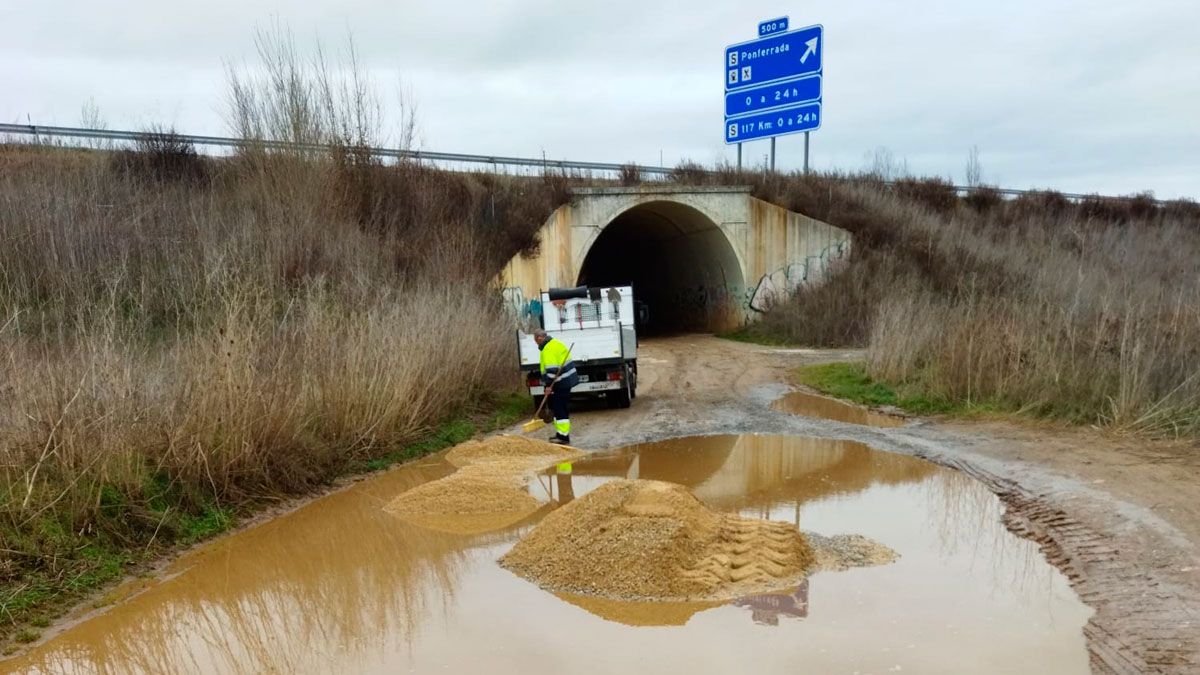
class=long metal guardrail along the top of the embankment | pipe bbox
[0,124,1168,205]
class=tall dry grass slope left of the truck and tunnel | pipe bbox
[0,28,566,641]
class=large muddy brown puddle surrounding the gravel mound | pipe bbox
[0,436,1091,674]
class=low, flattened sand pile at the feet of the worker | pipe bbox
[388,436,583,534]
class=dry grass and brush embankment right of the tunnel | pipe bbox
[678,167,1200,436]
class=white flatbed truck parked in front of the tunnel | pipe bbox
[517,286,637,408]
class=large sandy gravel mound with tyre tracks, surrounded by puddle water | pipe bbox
[500,480,814,601]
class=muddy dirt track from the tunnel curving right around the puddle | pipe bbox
[572,335,1200,673]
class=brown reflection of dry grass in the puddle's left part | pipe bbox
[8,456,501,673]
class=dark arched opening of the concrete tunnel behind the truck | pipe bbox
[578,202,745,334]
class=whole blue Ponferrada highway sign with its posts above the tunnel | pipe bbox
[725,22,824,172]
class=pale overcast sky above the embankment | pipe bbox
[0,0,1200,198]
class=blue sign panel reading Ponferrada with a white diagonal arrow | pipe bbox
[725,25,824,91]
